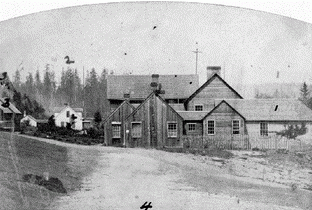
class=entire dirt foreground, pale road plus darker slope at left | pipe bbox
[0,136,312,210]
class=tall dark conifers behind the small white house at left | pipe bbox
[13,64,113,118]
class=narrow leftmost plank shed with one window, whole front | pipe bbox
[103,100,135,146]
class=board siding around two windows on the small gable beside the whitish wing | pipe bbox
[204,103,245,137]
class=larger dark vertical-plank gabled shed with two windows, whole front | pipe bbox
[125,92,183,148]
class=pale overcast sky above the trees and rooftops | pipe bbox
[0,0,312,90]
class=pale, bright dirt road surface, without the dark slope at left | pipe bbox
[47,147,311,209]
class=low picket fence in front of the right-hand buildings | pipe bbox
[182,135,306,151]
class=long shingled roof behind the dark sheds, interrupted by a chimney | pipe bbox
[107,74,199,99]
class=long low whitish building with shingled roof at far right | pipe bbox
[226,99,312,138]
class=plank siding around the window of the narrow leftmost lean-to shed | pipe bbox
[104,103,133,145]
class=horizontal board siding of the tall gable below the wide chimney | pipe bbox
[187,77,240,111]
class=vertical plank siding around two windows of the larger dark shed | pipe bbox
[126,95,183,148]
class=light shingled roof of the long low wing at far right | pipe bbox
[216,99,312,121]
